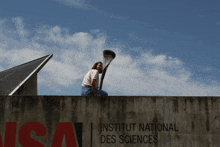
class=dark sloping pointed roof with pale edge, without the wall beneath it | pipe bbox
[0,54,53,95]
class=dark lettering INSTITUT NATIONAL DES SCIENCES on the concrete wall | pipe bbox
[100,123,178,144]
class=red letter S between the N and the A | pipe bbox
[18,122,46,147]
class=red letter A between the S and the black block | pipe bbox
[51,122,77,147]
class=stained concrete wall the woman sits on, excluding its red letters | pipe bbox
[0,96,220,147]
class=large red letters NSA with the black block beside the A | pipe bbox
[0,122,82,147]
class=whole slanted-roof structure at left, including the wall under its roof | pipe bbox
[0,54,53,96]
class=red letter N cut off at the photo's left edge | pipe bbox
[0,122,17,147]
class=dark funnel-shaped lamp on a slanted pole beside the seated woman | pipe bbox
[99,50,116,90]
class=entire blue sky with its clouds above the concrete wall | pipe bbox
[0,0,220,96]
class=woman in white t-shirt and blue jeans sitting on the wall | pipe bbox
[81,61,108,97]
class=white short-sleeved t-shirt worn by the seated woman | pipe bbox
[82,69,99,89]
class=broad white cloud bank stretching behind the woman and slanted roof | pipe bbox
[0,18,220,96]
